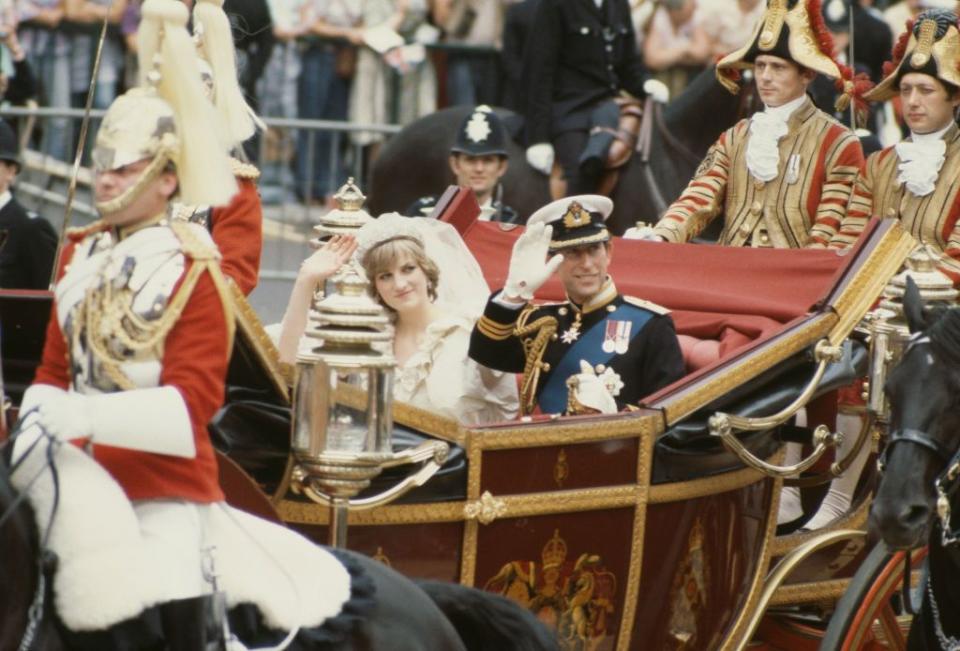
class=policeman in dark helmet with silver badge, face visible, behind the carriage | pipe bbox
[407,104,519,224]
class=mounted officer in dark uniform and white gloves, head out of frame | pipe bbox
[523,0,645,194]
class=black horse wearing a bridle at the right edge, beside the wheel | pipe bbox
[869,281,960,651]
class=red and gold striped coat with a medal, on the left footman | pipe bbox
[655,98,863,248]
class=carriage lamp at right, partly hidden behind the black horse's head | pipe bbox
[863,244,958,425]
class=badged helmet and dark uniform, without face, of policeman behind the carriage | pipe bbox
[404,104,520,224]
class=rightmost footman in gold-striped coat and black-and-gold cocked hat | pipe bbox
[831,9,960,285]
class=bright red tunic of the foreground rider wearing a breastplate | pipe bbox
[34,229,229,502]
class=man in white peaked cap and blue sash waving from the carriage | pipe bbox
[470,195,684,413]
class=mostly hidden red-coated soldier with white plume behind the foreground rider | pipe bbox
[172,0,263,295]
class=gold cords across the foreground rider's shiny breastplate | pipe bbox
[71,224,236,390]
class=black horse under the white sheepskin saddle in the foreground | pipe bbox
[0,432,558,651]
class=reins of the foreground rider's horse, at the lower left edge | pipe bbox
[0,409,61,651]
